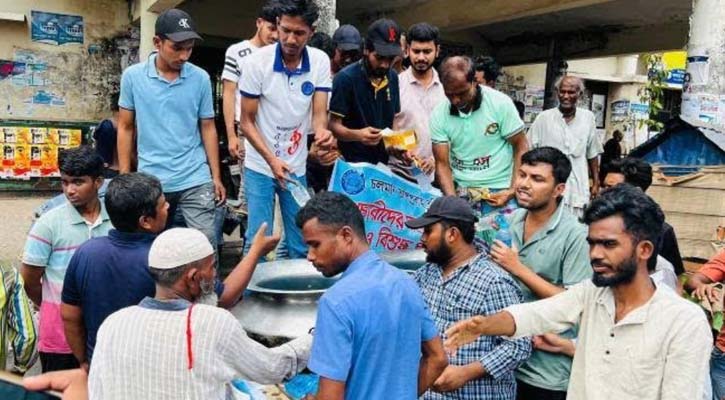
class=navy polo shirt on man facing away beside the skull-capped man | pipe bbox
[61,229,156,360]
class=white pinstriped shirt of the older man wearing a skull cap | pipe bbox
[89,304,312,400]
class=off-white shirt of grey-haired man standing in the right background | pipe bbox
[528,108,604,208]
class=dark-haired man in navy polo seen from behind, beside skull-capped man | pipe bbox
[60,173,169,368]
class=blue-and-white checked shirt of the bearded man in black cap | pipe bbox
[414,244,531,400]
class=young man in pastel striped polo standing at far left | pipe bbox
[20,146,112,372]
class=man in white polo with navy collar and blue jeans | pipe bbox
[239,0,334,258]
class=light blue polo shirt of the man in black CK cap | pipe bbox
[118,53,214,192]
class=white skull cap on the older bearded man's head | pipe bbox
[149,228,214,269]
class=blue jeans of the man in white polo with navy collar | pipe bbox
[244,168,307,258]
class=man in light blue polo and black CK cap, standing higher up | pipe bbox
[118,9,226,245]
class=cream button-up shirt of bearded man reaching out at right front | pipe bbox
[506,281,712,400]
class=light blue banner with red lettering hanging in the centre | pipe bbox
[329,160,441,251]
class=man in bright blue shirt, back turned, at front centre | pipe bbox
[297,192,448,400]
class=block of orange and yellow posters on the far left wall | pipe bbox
[0,126,82,179]
